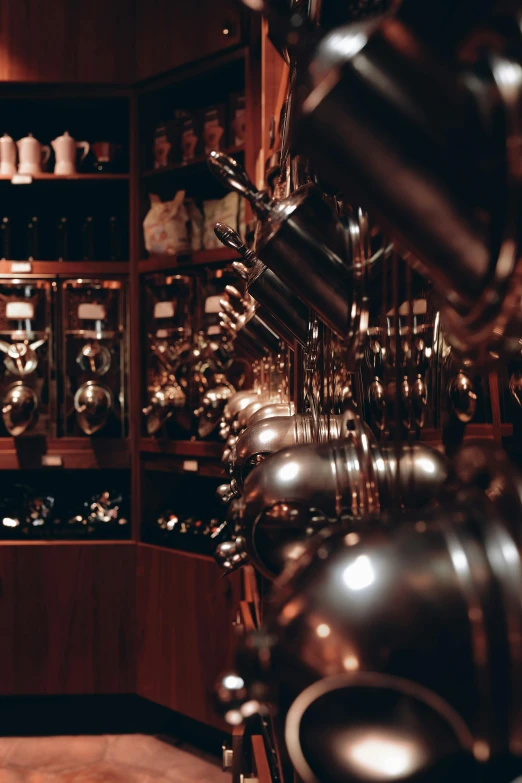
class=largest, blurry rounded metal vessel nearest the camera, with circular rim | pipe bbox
[239,494,522,783]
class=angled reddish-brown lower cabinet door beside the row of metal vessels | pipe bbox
[137,544,240,728]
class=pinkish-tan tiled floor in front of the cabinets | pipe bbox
[0,734,230,783]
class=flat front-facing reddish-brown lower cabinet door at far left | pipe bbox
[0,542,136,696]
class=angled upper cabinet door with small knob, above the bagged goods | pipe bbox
[136,0,241,80]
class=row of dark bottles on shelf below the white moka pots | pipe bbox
[0,215,125,261]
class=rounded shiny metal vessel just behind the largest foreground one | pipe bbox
[240,438,450,579]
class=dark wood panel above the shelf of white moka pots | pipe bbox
[0,0,133,82]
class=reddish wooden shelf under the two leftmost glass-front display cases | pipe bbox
[0,435,130,470]
